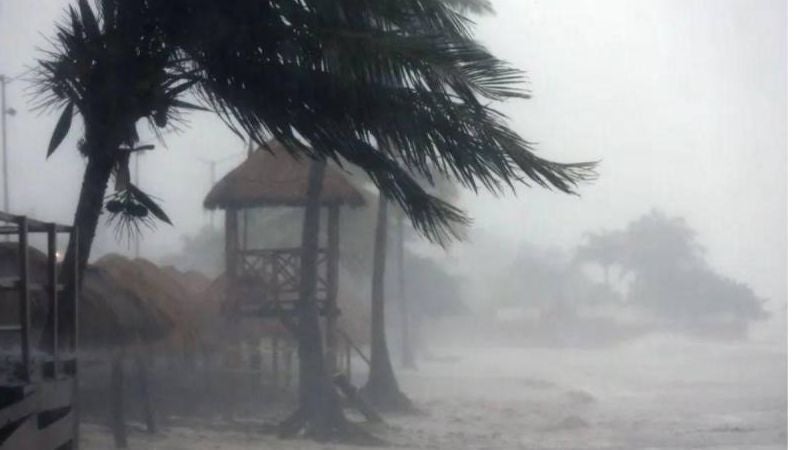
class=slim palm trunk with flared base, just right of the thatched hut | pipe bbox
[362,194,411,411]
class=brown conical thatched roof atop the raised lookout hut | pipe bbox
[203,141,364,209]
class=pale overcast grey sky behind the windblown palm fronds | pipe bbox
[0,0,787,308]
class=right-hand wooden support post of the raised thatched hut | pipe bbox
[325,204,339,374]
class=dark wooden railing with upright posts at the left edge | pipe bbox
[0,212,78,450]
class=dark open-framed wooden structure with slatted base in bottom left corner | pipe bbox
[0,213,78,450]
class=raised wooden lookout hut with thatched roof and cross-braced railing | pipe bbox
[204,141,364,368]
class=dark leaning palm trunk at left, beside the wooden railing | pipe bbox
[39,135,114,352]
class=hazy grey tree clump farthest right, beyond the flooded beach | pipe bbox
[579,210,767,337]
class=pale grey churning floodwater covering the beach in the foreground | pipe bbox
[82,337,787,450]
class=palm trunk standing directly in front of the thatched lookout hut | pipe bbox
[281,161,350,440]
